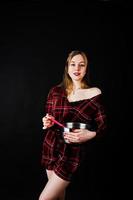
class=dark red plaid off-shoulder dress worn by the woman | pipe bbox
[41,86,106,181]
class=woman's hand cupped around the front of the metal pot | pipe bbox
[64,129,96,143]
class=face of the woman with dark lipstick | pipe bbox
[68,54,87,81]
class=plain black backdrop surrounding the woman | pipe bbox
[0,1,132,200]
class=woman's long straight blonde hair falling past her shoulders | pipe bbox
[60,50,89,95]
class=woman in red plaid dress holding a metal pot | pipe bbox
[39,51,106,200]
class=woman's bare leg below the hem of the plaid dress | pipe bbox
[39,171,70,200]
